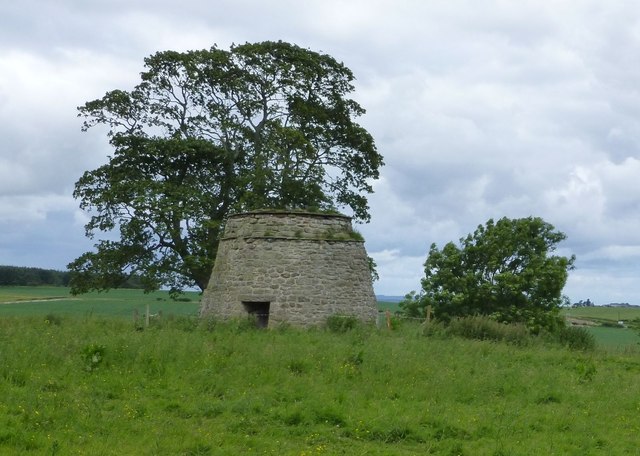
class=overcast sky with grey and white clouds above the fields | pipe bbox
[0,0,640,304]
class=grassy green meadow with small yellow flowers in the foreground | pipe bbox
[0,290,640,456]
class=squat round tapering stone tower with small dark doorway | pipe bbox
[200,211,377,327]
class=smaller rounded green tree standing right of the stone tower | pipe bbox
[400,217,575,332]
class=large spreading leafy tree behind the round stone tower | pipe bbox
[69,42,383,293]
